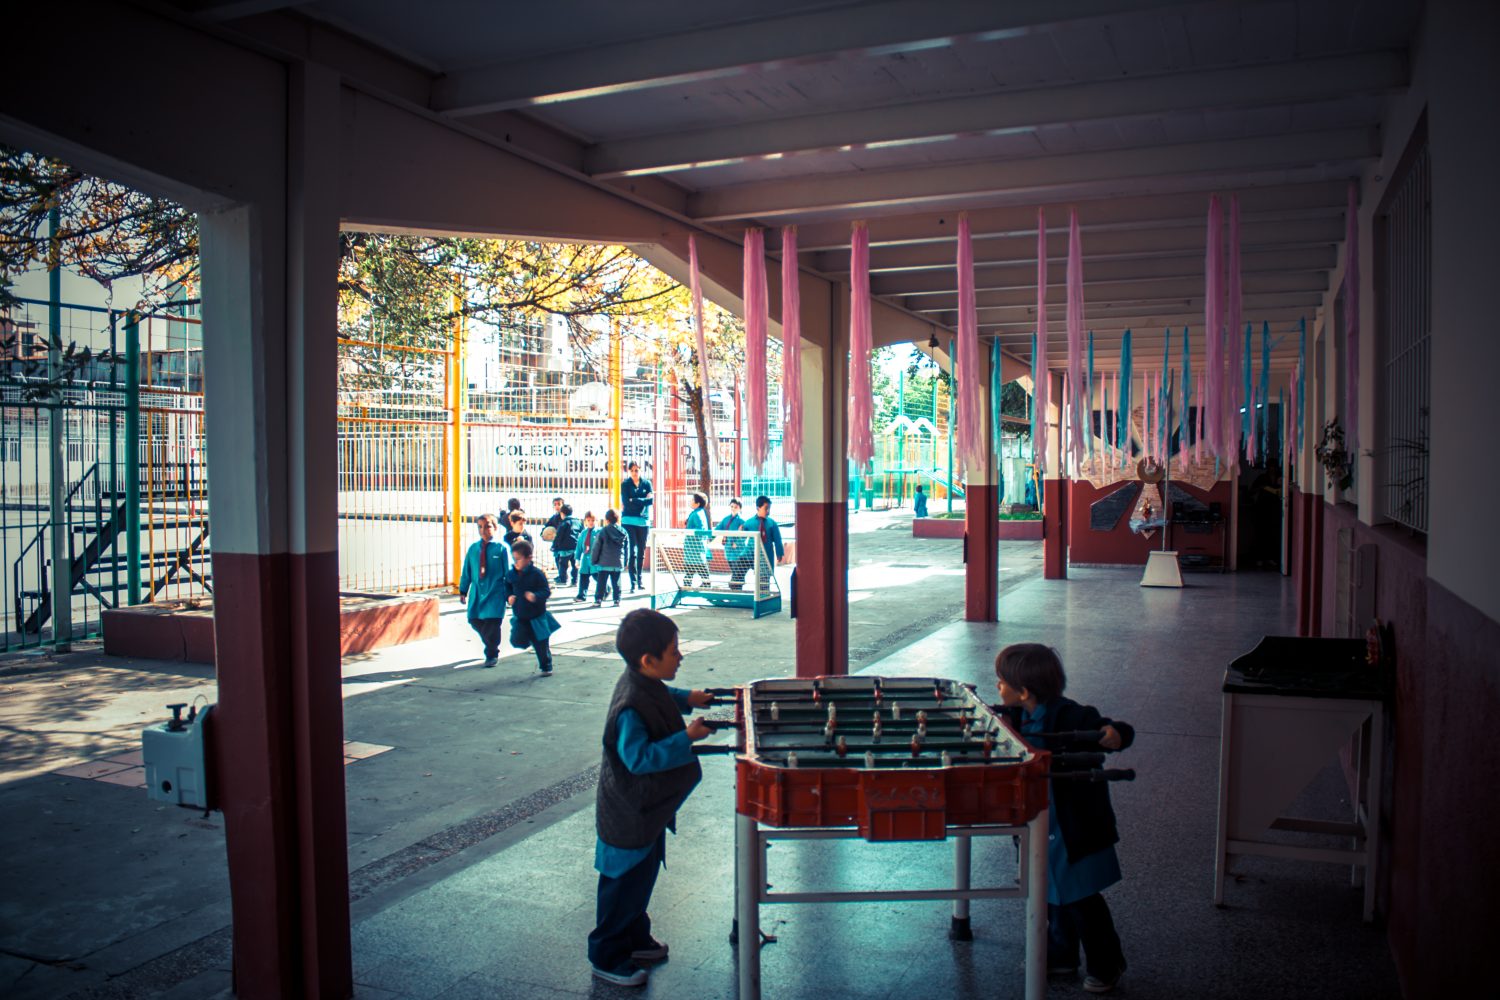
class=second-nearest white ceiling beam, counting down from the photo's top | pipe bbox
[584,52,1407,184]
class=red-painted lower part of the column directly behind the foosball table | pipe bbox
[797,501,849,678]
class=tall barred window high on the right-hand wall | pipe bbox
[1376,123,1433,532]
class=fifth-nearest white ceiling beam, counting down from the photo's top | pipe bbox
[800,217,1344,280]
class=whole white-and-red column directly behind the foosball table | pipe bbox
[797,280,849,678]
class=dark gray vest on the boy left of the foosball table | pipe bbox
[594,669,704,850]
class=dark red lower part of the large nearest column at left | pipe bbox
[209,552,354,1000]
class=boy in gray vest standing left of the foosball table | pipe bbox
[588,609,713,987]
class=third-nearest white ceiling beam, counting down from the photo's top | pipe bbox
[687,127,1380,222]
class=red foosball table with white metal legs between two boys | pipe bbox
[699,676,1130,1000]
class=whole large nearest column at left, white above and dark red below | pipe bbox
[201,66,353,999]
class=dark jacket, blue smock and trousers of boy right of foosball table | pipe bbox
[1008,696,1136,982]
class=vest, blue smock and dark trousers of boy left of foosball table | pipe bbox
[588,669,704,972]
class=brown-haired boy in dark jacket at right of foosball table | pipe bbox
[995,643,1136,993]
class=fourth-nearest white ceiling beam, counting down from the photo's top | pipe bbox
[786,180,1349,253]
